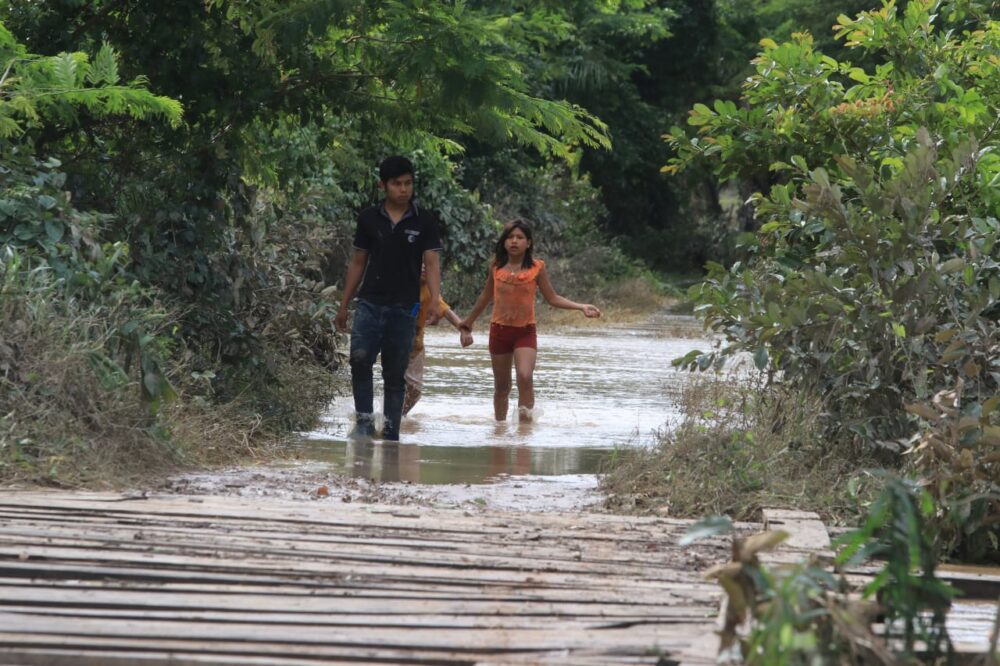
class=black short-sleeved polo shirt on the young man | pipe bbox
[354,204,441,307]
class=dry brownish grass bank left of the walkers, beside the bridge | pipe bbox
[0,276,333,487]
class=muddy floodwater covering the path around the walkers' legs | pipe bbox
[303,316,706,484]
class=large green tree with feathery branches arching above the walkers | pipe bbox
[8,0,607,290]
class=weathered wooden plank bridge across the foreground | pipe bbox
[0,490,729,666]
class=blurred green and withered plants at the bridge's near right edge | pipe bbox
[685,477,956,666]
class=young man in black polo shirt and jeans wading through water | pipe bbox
[335,155,441,441]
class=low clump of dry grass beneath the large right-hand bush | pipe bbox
[602,370,877,522]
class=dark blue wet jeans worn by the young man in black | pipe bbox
[351,299,417,439]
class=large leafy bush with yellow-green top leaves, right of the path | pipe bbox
[667,0,1000,452]
